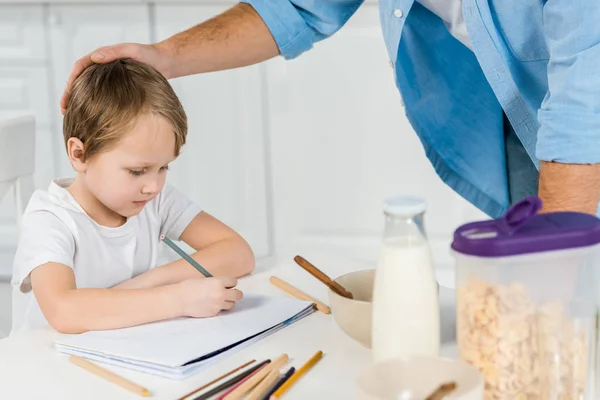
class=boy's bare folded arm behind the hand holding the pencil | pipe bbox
[114,211,255,289]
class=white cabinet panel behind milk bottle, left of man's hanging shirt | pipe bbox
[267,3,486,265]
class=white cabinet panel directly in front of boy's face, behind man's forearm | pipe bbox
[156,4,272,257]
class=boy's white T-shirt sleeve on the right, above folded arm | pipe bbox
[158,183,202,240]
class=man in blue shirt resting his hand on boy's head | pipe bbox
[61,0,600,217]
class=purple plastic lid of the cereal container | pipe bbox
[452,196,600,257]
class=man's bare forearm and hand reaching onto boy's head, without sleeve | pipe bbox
[60,3,279,113]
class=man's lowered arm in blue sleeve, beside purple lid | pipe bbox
[537,0,600,215]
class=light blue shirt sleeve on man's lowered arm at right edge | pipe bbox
[536,0,600,164]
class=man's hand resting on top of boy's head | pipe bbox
[60,43,168,114]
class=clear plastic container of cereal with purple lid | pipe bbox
[452,197,600,400]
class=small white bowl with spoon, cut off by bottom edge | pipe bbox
[356,356,484,400]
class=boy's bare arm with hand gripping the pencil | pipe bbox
[31,263,241,333]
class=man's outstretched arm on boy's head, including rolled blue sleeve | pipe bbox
[60,0,364,113]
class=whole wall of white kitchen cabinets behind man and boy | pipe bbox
[0,0,485,337]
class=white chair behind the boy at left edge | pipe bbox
[0,115,35,338]
